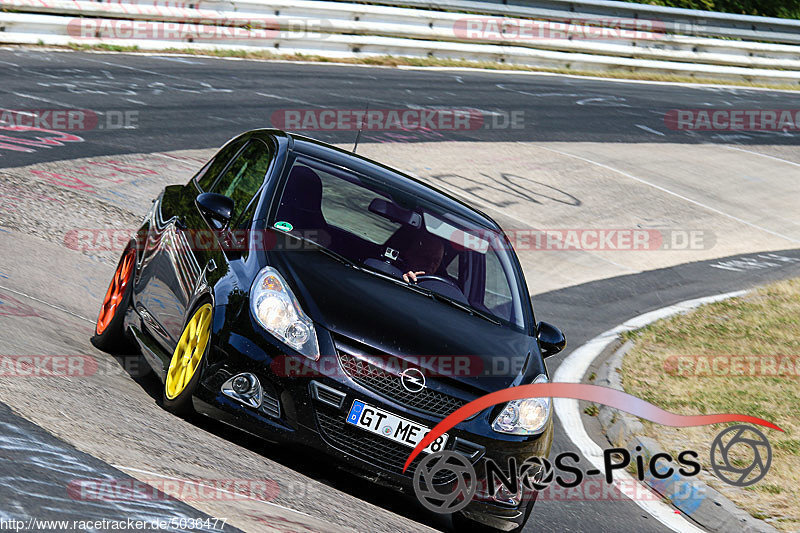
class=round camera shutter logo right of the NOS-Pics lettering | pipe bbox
[711,425,772,487]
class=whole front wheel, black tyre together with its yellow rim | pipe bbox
[162,302,212,417]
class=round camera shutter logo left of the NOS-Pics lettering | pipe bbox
[414,451,478,513]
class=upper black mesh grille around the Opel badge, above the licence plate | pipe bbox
[337,350,467,418]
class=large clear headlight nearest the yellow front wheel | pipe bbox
[250,267,319,361]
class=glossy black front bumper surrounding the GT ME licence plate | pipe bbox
[194,306,553,529]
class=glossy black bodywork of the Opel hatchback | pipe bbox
[120,130,553,523]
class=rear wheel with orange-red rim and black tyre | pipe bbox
[91,246,136,353]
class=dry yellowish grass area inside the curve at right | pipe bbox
[622,279,800,531]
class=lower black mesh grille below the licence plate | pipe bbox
[316,406,456,485]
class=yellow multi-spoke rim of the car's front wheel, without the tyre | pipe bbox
[164,304,211,410]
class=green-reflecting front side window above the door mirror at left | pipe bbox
[210,139,272,221]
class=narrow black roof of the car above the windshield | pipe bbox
[261,130,502,232]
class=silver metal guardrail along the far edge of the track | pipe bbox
[0,0,800,83]
